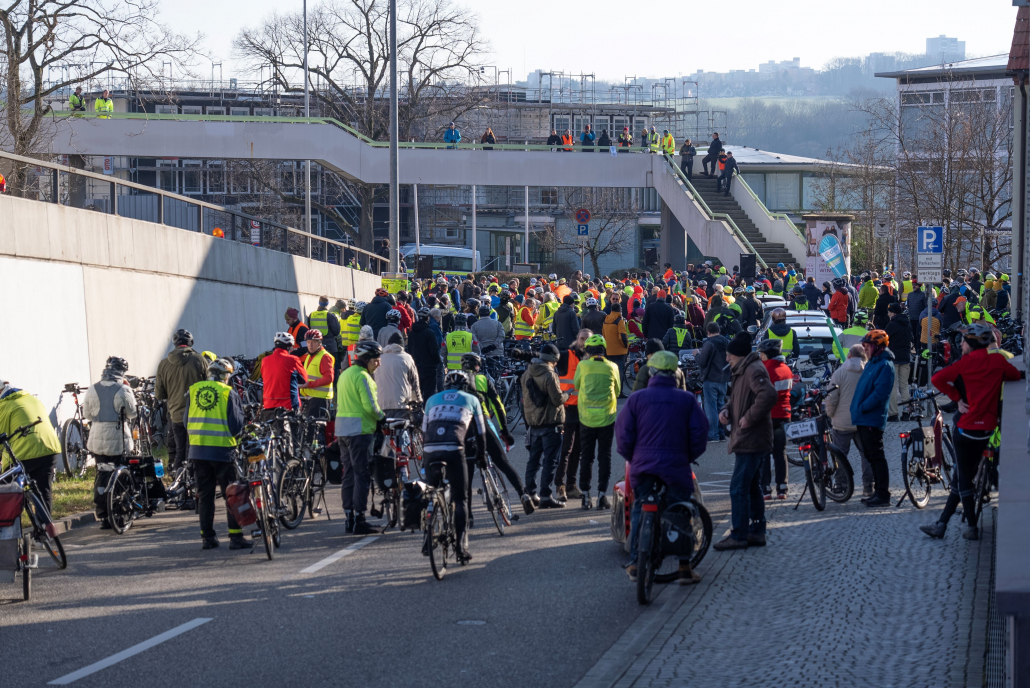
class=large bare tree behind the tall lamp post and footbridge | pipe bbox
[235,0,486,249]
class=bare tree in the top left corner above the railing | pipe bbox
[0,0,200,193]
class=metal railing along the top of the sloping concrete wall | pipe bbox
[0,150,389,274]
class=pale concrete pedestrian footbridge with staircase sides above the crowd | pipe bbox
[53,113,804,268]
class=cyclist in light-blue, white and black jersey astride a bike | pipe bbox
[422,370,486,561]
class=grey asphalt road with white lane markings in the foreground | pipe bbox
[0,399,731,688]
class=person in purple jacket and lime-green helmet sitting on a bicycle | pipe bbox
[616,351,709,585]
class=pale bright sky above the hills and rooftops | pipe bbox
[160,0,1016,81]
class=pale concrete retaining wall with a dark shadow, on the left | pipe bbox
[0,196,380,414]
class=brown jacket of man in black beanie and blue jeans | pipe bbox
[723,351,778,454]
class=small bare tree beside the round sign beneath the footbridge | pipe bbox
[542,186,640,276]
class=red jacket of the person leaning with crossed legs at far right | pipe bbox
[930,349,1020,433]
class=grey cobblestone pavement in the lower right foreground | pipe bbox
[578,423,993,688]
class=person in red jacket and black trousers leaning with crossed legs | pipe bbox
[919,322,1022,540]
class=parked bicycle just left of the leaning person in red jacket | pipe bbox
[897,387,956,509]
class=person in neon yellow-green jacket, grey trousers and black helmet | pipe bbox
[336,340,386,535]
